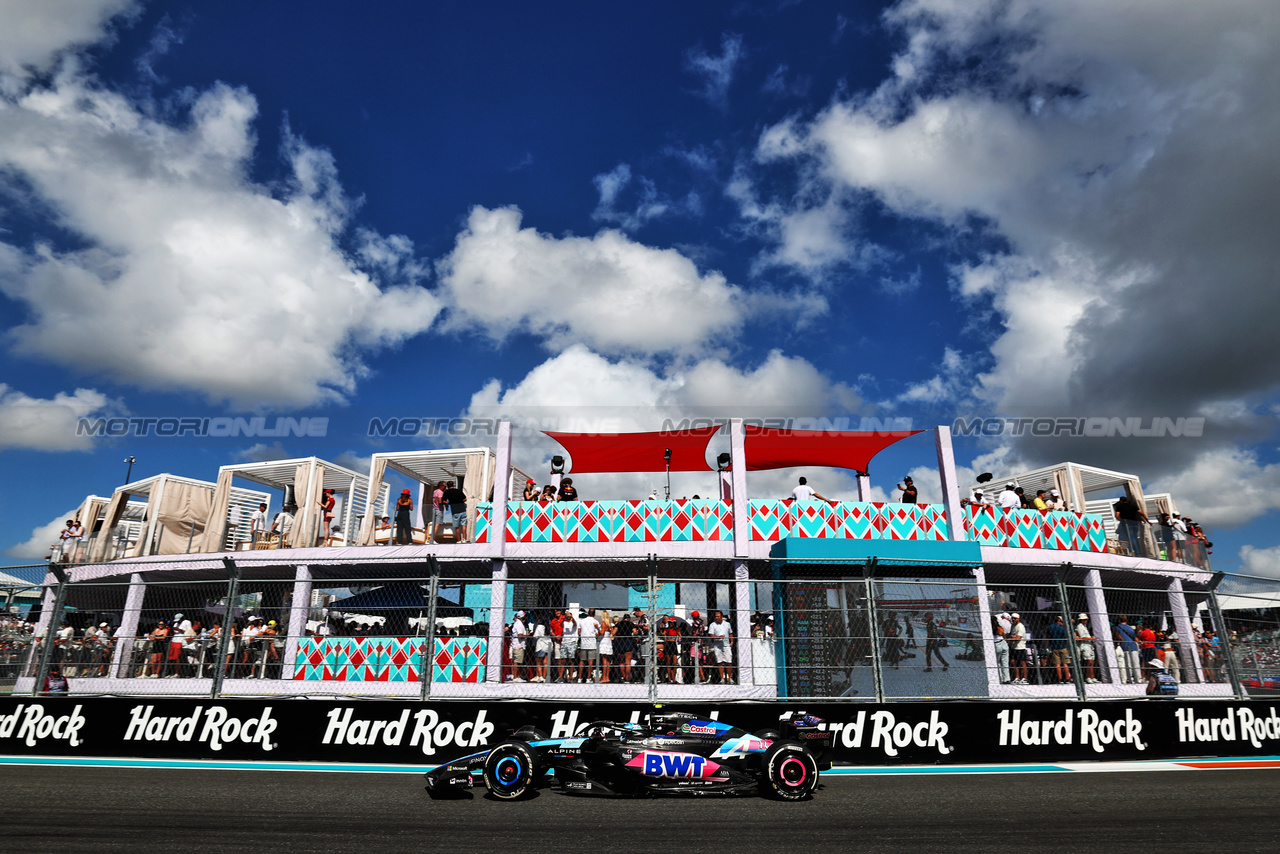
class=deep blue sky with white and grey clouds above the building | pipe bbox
[0,0,1280,574]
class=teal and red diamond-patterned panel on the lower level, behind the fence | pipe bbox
[293,638,489,682]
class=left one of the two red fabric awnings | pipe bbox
[545,425,719,475]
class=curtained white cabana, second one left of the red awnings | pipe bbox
[202,457,387,552]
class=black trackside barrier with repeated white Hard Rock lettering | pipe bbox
[0,695,1280,769]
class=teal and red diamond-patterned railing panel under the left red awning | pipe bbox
[507,498,733,543]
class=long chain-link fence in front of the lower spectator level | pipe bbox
[10,560,1280,702]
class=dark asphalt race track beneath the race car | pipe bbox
[0,766,1280,854]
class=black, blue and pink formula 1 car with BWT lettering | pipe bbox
[426,712,832,800]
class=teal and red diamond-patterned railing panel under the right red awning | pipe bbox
[749,498,947,542]
